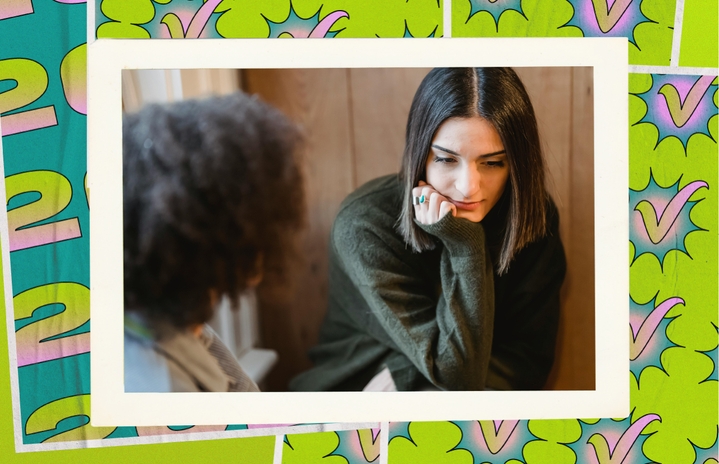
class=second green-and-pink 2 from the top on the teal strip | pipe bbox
[5,171,82,251]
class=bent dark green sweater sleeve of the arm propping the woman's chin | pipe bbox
[333,210,494,390]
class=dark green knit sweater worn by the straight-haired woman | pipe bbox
[290,175,565,391]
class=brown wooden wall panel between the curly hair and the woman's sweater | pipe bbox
[243,69,354,390]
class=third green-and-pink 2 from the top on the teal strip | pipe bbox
[13,282,90,367]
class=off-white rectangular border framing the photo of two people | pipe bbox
[88,38,629,426]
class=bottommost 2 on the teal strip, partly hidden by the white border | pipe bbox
[25,395,117,443]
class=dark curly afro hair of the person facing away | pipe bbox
[123,93,304,327]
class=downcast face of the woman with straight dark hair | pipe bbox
[426,116,509,222]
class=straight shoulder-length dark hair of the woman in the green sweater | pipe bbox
[398,68,548,274]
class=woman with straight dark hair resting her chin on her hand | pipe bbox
[291,68,566,391]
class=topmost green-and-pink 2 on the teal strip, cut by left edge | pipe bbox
[0,58,57,136]
